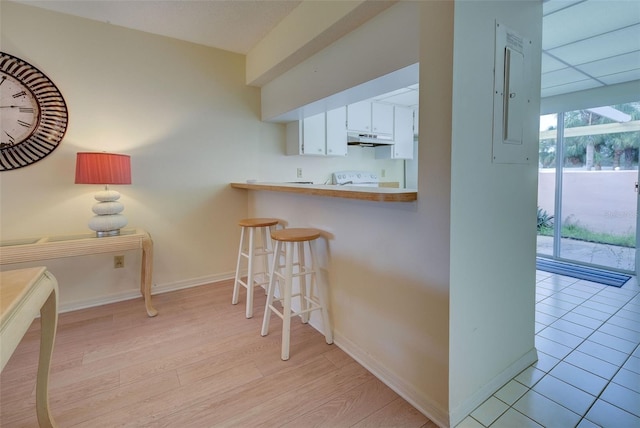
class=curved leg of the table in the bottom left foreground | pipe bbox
[36,273,58,427]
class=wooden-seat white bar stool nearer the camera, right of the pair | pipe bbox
[261,228,333,361]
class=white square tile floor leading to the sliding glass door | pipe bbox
[458,271,640,428]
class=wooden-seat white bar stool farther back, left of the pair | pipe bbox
[231,218,280,318]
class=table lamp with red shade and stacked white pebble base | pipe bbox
[76,152,131,237]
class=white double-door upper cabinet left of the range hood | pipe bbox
[286,107,347,156]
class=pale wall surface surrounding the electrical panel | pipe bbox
[448,1,542,420]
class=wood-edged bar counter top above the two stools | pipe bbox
[231,182,418,202]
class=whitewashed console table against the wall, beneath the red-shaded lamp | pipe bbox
[0,229,158,317]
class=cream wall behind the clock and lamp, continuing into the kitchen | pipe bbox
[0,1,403,313]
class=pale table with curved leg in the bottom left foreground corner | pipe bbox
[0,267,58,427]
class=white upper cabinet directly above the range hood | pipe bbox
[347,101,393,136]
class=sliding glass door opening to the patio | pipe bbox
[538,103,640,273]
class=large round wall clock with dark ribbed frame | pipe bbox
[0,52,68,171]
